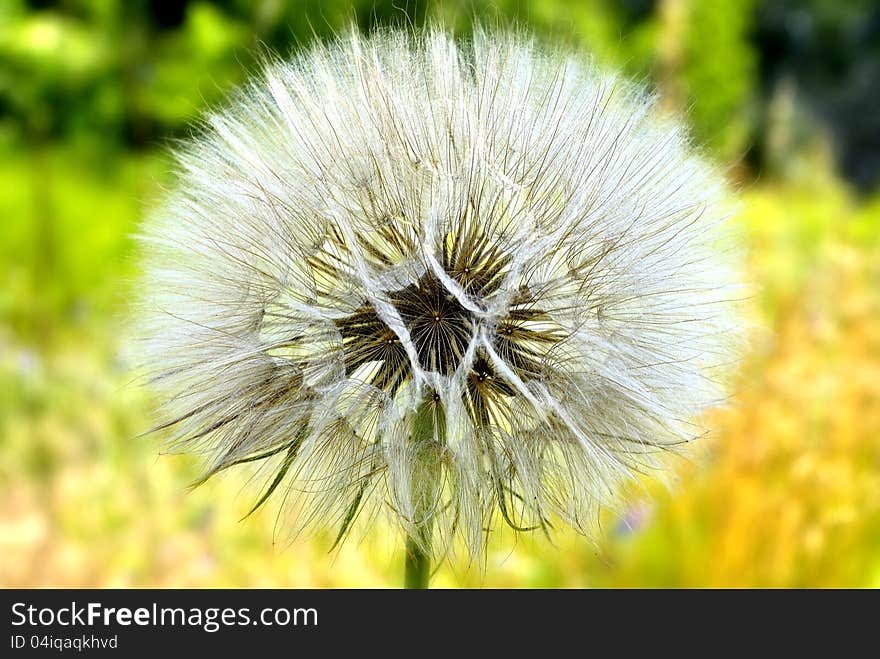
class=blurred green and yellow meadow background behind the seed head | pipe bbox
[0,0,880,587]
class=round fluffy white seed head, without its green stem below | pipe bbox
[138,31,738,564]
